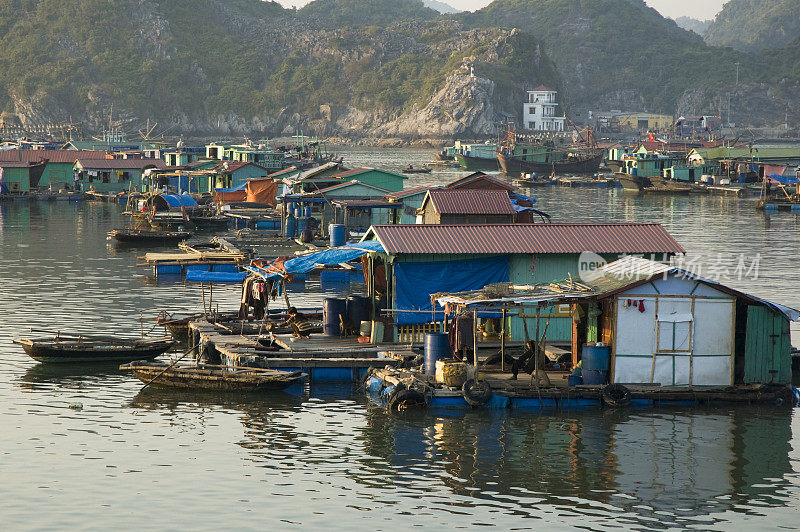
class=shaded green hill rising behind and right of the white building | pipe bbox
[463,0,743,113]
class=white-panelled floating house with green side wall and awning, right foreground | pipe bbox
[439,256,800,388]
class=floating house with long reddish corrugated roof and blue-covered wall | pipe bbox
[363,224,685,342]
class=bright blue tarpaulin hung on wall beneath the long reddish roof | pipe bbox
[394,256,510,325]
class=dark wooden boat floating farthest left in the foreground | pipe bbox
[14,336,175,363]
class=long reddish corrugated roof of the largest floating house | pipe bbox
[371,223,686,254]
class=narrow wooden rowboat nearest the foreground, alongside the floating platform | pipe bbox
[119,361,308,392]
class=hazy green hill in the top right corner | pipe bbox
[704,0,800,52]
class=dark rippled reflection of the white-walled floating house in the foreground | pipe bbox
[354,408,793,527]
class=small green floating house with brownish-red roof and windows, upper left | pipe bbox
[74,159,166,192]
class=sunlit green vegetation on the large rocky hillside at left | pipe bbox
[0,0,557,132]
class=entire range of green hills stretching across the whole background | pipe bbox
[0,0,800,134]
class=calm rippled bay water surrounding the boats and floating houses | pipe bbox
[0,150,800,530]
